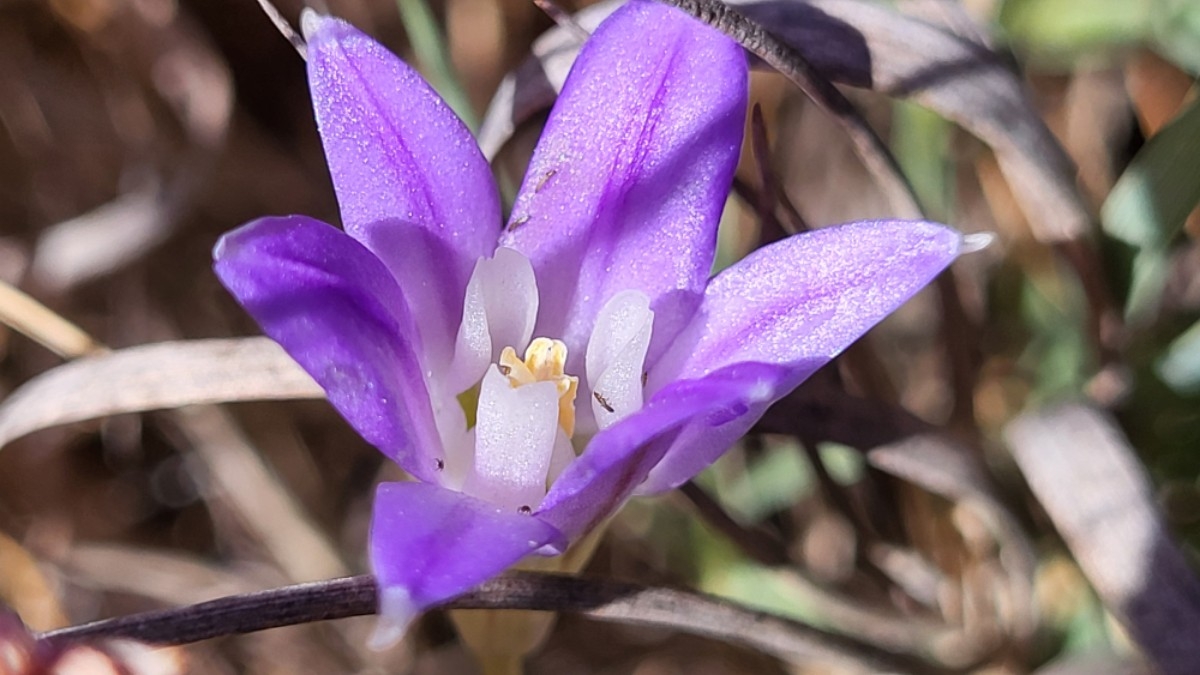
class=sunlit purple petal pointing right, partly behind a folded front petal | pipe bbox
[638,221,962,494]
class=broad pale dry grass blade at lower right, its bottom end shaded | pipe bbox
[1004,404,1200,675]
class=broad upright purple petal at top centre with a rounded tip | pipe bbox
[500,0,746,370]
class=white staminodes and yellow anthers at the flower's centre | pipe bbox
[431,249,654,510]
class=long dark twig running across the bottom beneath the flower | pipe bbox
[41,573,941,673]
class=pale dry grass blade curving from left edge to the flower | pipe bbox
[0,338,324,448]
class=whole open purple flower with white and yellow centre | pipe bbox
[215,0,961,625]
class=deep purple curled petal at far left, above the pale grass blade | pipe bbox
[212,216,442,480]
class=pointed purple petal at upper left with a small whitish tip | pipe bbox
[304,12,500,357]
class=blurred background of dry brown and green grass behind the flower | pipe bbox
[0,0,1200,675]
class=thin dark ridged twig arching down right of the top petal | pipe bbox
[661,0,922,219]
